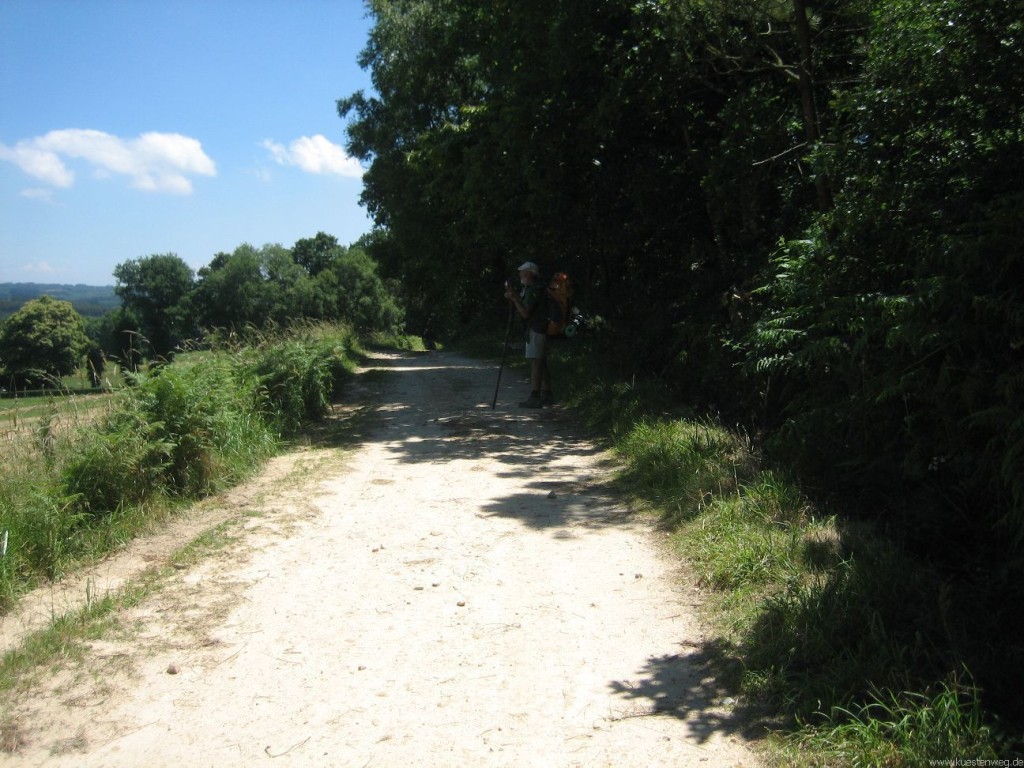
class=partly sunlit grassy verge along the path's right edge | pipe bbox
[554,345,1021,766]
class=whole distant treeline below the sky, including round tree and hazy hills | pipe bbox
[0,232,404,391]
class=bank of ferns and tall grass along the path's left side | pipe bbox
[0,326,411,612]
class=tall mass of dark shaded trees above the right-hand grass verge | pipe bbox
[338,0,1024,733]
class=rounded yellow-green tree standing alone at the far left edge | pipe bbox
[0,296,89,387]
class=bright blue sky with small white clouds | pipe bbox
[0,0,371,286]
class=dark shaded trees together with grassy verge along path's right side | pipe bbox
[346,0,1024,764]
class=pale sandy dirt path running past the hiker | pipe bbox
[0,352,757,768]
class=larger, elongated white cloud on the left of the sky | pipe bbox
[0,128,217,195]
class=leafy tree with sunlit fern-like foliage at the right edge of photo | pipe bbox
[754,0,1024,518]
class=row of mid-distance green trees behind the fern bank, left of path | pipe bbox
[105,232,404,360]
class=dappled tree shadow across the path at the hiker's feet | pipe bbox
[307,353,628,528]
